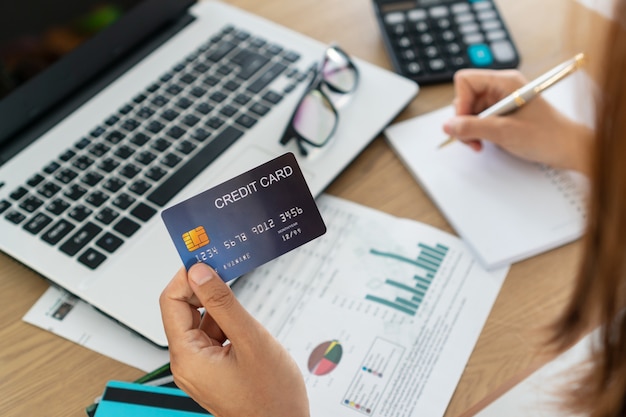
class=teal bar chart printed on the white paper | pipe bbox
[365,243,448,316]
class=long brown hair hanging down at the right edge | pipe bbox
[554,0,626,417]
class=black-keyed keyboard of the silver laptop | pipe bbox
[0,26,309,269]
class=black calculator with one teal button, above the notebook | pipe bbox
[373,0,520,84]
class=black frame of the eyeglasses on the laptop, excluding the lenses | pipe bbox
[279,44,359,156]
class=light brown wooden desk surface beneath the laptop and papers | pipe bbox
[0,0,580,417]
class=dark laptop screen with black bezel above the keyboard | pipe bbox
[0,0,192,164]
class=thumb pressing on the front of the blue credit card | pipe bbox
[187,263,259,343]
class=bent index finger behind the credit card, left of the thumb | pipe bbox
[159,268,200,344]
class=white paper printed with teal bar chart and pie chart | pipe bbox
[233,195,508,417]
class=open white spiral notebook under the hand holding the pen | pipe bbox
[385,72,593,268]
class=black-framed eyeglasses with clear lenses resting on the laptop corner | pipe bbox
[280,45,359,156]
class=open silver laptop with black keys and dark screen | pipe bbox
[0,0,418,347]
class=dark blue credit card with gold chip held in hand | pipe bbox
[161,153,326,281]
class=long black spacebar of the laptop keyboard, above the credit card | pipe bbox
[147,126,243,207]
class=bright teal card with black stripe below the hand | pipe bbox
[95,381,212,417]
